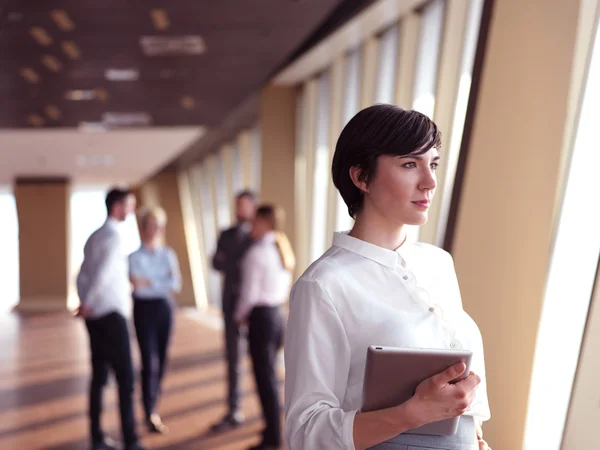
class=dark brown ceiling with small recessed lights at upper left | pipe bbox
[0,0,341,128]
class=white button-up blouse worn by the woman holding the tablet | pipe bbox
[285,233,490,450]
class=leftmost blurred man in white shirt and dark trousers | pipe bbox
[77,189,143,450]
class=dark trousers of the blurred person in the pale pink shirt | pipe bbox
[248,307,283,446]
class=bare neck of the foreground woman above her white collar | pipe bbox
[349,207,406,250]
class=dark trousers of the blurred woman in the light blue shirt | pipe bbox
[133,298,173,418]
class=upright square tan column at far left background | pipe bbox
[14,179,71,312]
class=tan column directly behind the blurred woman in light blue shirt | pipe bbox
[139,171,196,307]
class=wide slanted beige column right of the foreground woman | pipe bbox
[452,0,579,450]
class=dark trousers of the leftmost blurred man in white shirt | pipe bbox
[86,313,137,446]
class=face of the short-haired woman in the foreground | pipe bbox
[363,148,440,225]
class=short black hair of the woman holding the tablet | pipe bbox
[331,104,442,218]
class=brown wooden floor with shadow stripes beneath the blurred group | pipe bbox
[0,312,282,450]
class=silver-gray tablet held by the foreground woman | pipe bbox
[361,345,472,436]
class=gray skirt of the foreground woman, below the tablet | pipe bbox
[368,416,479,450]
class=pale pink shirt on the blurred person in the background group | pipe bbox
[234,232,292,322]
